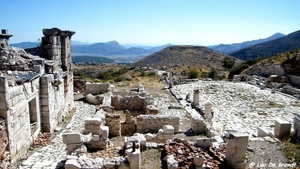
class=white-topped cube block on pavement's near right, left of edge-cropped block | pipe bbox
[274,119,292,139]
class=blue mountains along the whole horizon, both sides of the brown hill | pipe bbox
[12,31,300,63]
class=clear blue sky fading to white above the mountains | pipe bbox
[0,0,300,46]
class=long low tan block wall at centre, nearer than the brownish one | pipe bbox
[136,115,180,133]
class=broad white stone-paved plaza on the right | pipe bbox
[172,81,300,137]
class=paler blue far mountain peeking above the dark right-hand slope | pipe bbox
[208,33,285,54]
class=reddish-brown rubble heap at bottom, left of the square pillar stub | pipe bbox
[163,138,229,168]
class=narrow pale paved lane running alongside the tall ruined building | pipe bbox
[19,101,95,169]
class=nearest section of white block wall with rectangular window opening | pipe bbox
[0,77,41,162]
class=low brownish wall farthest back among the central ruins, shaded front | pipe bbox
[111,95,147,110]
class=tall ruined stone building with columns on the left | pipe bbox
[0,28,75,162]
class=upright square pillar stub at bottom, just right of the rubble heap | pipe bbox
[225,132,249,169]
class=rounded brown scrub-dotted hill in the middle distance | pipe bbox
[133,46,240,70]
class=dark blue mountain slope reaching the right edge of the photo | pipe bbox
[229,30,300,60]
